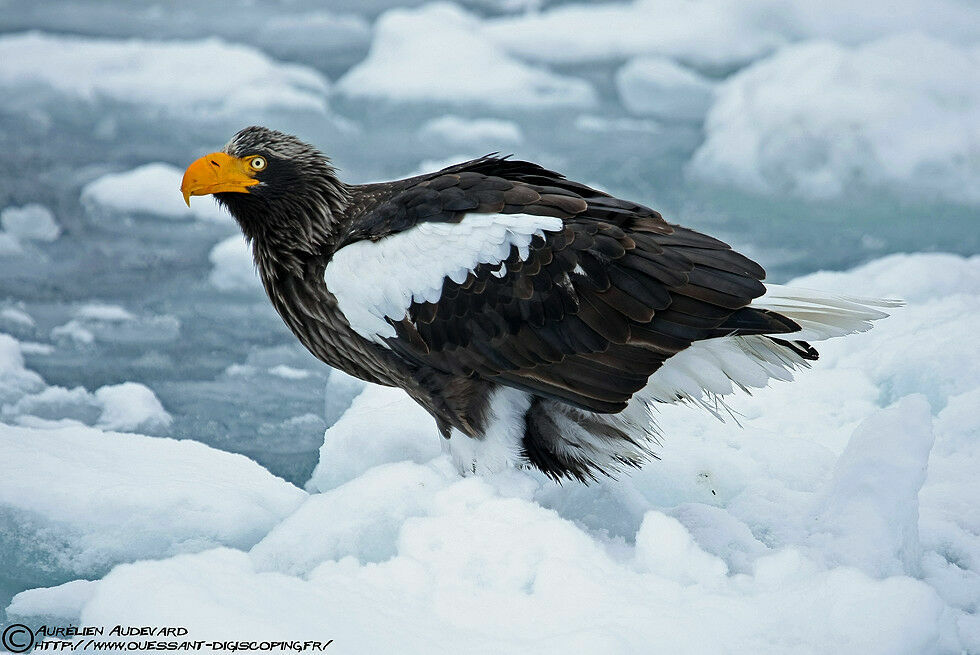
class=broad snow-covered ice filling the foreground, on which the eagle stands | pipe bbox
[0,255,980,654]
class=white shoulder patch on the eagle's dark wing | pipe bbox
[324,214,563,343]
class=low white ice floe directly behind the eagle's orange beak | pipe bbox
[82,162,231,222]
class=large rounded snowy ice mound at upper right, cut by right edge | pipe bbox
[689,34,980,204]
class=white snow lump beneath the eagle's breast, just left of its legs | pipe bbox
[306,384,442,491]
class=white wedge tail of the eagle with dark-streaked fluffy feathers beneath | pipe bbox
[523,285,903,482]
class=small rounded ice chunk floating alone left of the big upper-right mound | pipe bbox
[616,57,714,120]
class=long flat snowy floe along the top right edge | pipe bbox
[484,0,980,70]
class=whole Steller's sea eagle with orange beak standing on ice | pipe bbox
[181,127,894,481]
